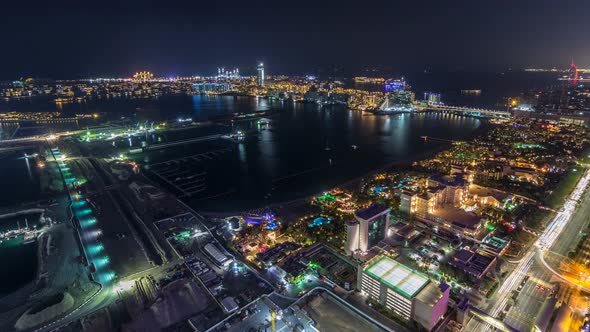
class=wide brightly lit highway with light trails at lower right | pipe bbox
[465,171,590,332]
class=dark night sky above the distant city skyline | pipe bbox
[0,0,590,79]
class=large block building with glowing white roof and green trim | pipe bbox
[358,256,450,331]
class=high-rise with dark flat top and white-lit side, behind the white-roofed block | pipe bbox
[354,203,390,251]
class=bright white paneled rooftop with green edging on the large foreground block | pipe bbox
[365,256,430,298]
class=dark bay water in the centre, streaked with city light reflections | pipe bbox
[121,96,482,211]
